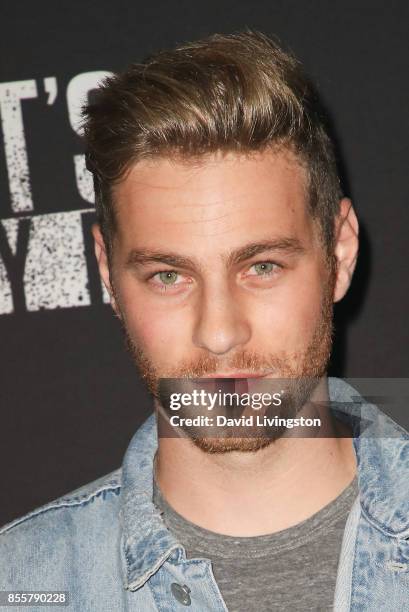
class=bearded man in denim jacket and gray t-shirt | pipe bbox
[0,32,409,612]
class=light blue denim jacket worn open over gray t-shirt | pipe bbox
[0,379,409,612]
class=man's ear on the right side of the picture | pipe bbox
[334,198,359,302]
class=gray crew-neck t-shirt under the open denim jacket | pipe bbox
[153,470,358,612]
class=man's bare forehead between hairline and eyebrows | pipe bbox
[113,151,312,254]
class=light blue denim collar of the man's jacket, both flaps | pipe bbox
[121,378,409,590]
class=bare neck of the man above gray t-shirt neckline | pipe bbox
[155,378,356,536]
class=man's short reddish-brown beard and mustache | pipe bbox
[117,258,336,453]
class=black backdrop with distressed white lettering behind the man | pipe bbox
[0,0,409,524]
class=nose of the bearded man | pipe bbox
[193,286,251,355]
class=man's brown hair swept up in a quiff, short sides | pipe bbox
[83,31,342,259]
